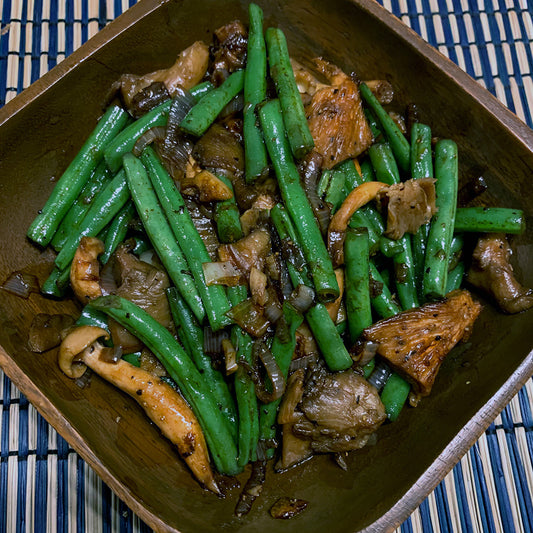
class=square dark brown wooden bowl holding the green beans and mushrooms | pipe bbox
[0,0,533,533]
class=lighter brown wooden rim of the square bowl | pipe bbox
[0,0,533,533]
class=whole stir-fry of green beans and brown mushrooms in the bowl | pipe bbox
[13,4,533,518]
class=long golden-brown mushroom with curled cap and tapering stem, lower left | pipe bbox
[59,326,220,494]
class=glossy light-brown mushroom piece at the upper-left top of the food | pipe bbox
[119,41,209,112]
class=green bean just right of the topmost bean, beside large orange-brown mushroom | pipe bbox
[265,28,315,159]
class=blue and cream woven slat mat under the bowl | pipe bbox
[0,0,533,533]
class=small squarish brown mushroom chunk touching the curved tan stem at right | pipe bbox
[376,178,437,240]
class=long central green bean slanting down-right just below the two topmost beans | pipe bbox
[259,100,339,301]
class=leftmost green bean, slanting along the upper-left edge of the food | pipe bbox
[27,106,128,246]
